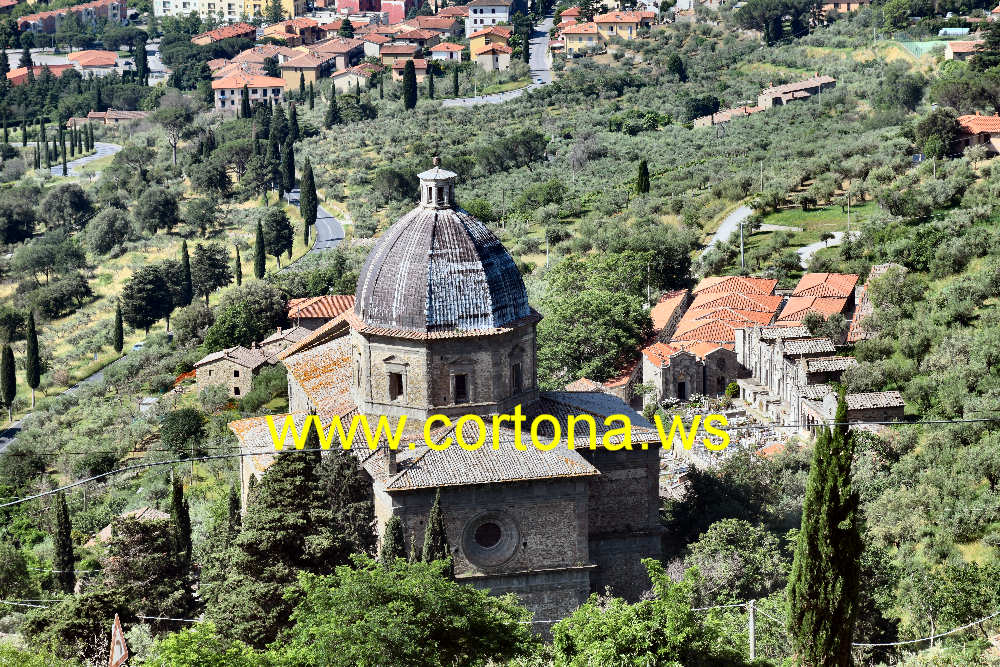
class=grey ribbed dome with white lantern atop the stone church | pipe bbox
[354,158,532,333]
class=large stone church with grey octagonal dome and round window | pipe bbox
[230,160,662,631]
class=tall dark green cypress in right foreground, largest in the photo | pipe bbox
[787,391,863,667]
